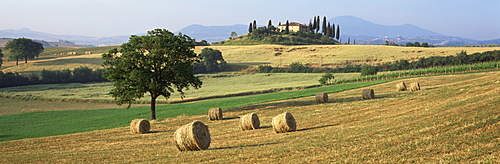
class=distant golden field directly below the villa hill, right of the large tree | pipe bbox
[195,45,499,67]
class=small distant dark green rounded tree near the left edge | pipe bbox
[5,38,43,65]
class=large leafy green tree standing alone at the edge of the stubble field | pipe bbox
[102,29,202,120]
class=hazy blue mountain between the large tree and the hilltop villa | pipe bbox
[177,24,248,43]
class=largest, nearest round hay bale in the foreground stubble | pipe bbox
[174,121,210,151]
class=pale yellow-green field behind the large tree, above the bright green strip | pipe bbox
[0,73,359,105]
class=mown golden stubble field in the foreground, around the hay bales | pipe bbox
[0,70,500,163]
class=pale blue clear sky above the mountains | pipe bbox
[0,0,500,40]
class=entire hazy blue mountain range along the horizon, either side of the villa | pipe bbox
[0,16,500,46]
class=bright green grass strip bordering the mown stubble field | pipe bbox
[0,80,390,141]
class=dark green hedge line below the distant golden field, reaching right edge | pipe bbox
[258,50,500,75]
